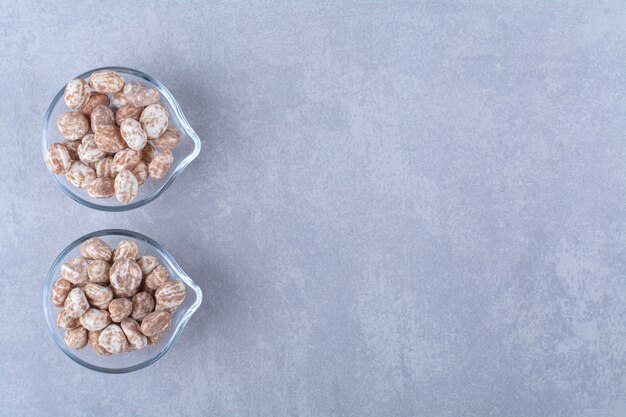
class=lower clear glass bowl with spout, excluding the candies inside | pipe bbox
[43,229,202,374]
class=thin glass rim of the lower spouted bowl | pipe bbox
[43,229,202,374]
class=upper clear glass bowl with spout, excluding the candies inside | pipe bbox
[42,67,200,211]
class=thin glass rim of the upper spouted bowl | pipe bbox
[41,66,202,212]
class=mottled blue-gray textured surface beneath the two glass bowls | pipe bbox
[0,0,626,417]
